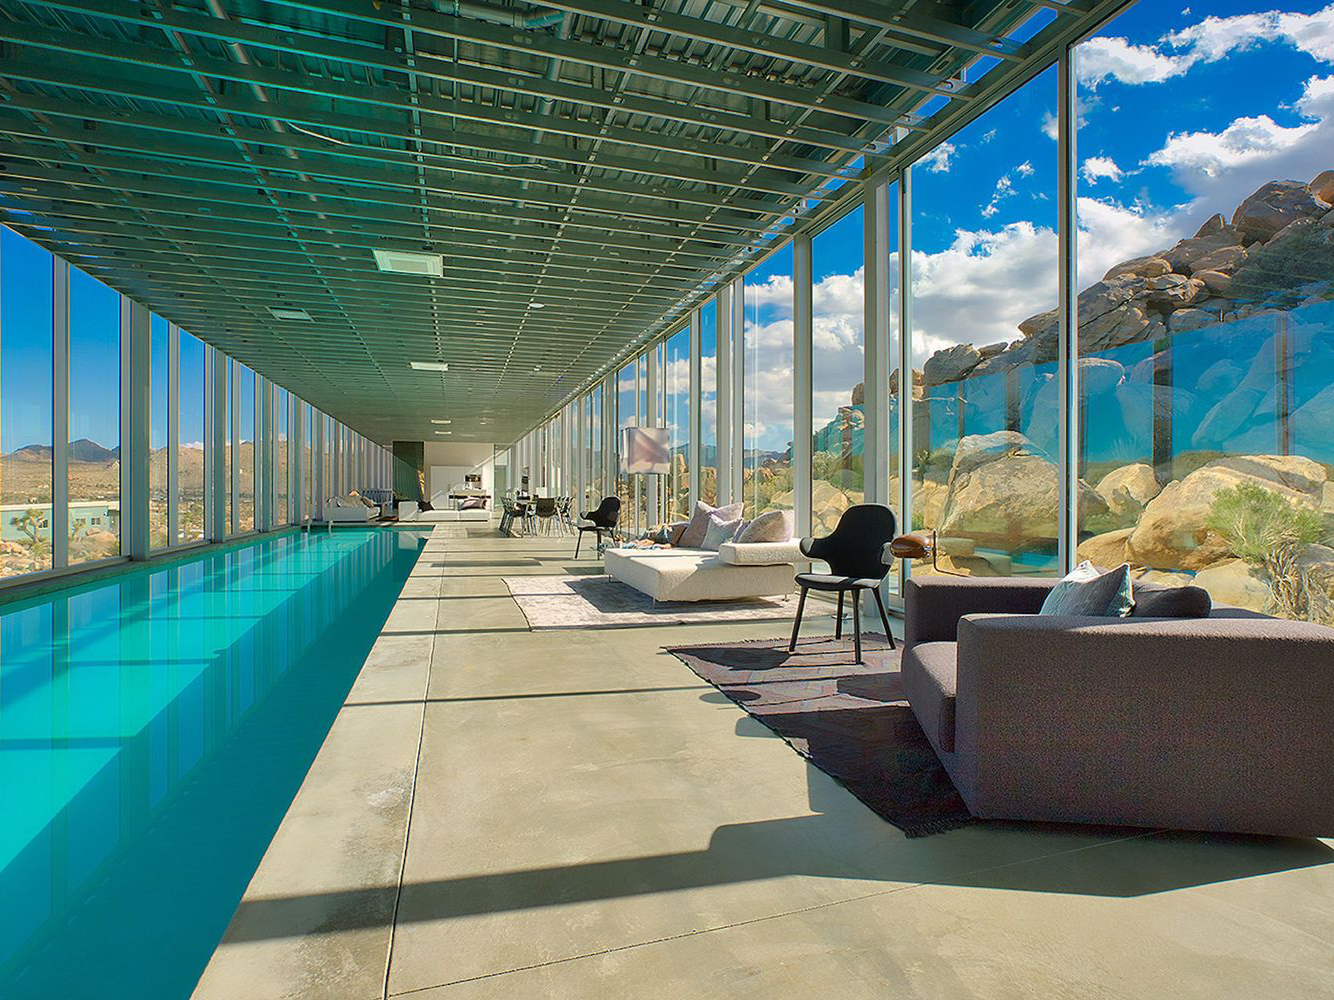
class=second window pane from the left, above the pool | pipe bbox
[65,267,120,565]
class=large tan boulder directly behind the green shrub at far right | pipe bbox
[1127,455,1327,571]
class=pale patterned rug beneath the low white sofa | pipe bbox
[504,575,810,631]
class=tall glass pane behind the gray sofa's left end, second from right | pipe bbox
[902,69,1059,576]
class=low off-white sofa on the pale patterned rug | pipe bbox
[604,539,804,601]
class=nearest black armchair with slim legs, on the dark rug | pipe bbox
[787,504,896,663]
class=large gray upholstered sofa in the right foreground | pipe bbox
[903,577,1334,836]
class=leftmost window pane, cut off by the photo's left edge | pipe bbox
[0,225,55,577]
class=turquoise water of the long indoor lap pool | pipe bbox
[0,528,426,1000]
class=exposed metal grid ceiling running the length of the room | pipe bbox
[0,0,1126,443]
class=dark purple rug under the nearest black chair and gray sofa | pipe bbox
[667,635,972,837]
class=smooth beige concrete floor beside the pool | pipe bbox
[196,528,1334,1000]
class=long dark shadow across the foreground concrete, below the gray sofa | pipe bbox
[228,796,1334,941]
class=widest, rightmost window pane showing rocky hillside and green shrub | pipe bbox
[1072,0,1334,624]
